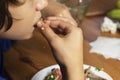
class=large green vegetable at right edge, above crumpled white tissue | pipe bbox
[107,9,120,20]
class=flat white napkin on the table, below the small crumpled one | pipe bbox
[90,36,120,60]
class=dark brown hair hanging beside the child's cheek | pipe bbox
[0,0,22,31]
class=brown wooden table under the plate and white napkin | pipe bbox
[4,16,120,80]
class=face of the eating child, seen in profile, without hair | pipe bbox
[0,0,47,40]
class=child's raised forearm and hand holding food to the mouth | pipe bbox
[37,17,84,80]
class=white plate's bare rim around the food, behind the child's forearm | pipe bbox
[31,64,113,80]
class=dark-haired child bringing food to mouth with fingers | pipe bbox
[0,0,84,80]
